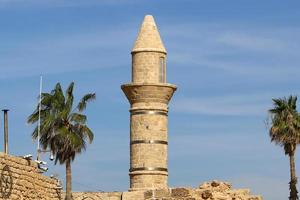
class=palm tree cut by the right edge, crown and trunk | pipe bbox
[269,96,300,200]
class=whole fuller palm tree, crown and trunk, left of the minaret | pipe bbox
[28,82,96,200]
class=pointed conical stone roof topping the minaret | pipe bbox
[131,15,167,53]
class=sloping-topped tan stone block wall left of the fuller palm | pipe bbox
[0,152,61,200]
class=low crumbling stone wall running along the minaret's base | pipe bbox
[67,181,262,200]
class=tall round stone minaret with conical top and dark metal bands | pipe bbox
[122,15,176,191]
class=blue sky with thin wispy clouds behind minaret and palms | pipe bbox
[0,0,300,200]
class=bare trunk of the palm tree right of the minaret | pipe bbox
[289,149,299,200]
